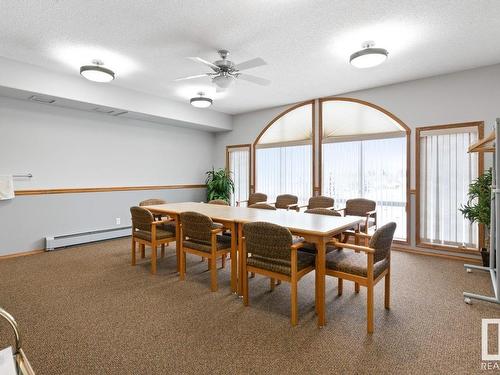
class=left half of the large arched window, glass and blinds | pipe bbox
[254,102,313,202]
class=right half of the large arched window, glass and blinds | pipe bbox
[320,98,409,240]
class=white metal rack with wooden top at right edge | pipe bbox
[463,118,500,304]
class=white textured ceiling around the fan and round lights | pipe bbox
[0,0,500,114]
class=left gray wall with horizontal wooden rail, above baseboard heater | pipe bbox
[0,97,215,255]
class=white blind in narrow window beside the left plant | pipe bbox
[228,147,250,206]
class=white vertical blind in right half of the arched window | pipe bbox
[322,137,406,240]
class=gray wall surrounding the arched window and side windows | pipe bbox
[215,65,500,245]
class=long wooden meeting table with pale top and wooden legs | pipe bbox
[145,202,365,327]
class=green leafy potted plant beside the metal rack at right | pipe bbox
[459,168,492,267]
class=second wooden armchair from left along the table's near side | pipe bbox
[180,211,231,292]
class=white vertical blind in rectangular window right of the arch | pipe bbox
[418,128,478,248]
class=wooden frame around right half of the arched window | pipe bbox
[318,96,411,245]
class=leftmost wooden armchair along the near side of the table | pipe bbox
[130,206,175,275]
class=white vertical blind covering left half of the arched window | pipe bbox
[255,144,312,202]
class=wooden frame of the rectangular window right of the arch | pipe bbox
[415,121,485,254]
